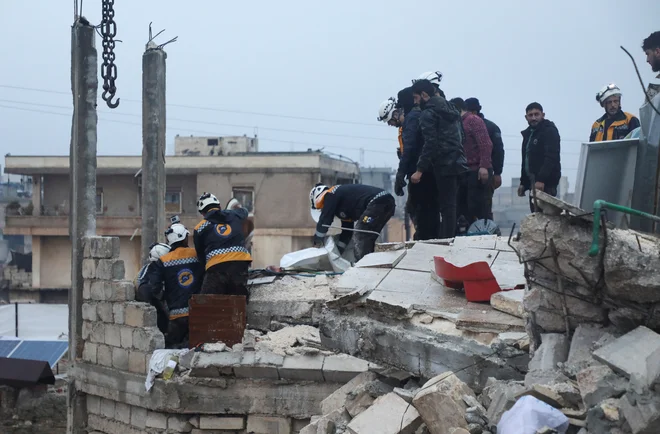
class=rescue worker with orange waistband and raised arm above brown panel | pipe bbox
[193,192,252,301]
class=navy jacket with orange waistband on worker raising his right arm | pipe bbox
[193,208,252,270]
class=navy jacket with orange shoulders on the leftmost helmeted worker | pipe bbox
[143,247,204,314]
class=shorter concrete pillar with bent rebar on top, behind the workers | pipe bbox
[142,45,167,260]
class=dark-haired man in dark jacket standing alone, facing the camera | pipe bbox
[518,102,561,212]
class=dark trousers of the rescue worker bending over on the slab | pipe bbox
[353,195,396,262]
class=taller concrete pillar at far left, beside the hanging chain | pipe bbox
[67,19,99,434]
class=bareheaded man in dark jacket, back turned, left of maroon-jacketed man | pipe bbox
[410,80,468,238]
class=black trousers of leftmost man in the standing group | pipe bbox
[407,172,440,240]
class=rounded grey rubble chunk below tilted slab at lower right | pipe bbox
[577,365,627,408]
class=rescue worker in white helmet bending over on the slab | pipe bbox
[309,184,396,262]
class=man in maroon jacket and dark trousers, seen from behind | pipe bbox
[451,98,493,224]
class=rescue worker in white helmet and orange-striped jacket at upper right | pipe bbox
[589,83,640,142]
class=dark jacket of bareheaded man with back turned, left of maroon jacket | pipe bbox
[417,96,468,176]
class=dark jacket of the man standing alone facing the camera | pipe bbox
[520,119,561,189]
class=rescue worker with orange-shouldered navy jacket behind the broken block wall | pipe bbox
[139,223,204,348]
